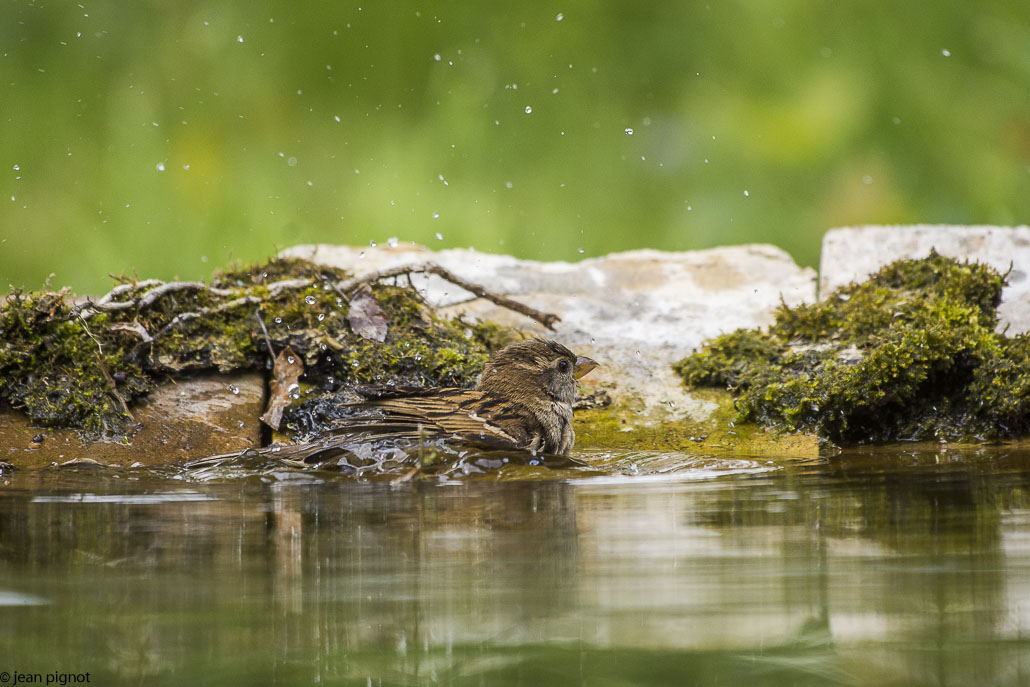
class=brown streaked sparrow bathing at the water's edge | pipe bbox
[237,339,597,463]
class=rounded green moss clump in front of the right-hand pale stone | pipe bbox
[676,252,1030,443]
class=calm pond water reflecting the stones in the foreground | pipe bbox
[0,447,1030,687]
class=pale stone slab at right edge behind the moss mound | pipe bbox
[819,225,1030,334]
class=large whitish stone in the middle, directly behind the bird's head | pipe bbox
[281,245,816,421]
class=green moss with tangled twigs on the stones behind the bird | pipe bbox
[0,260,509,438]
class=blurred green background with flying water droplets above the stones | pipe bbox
[0,0,1030,293]
